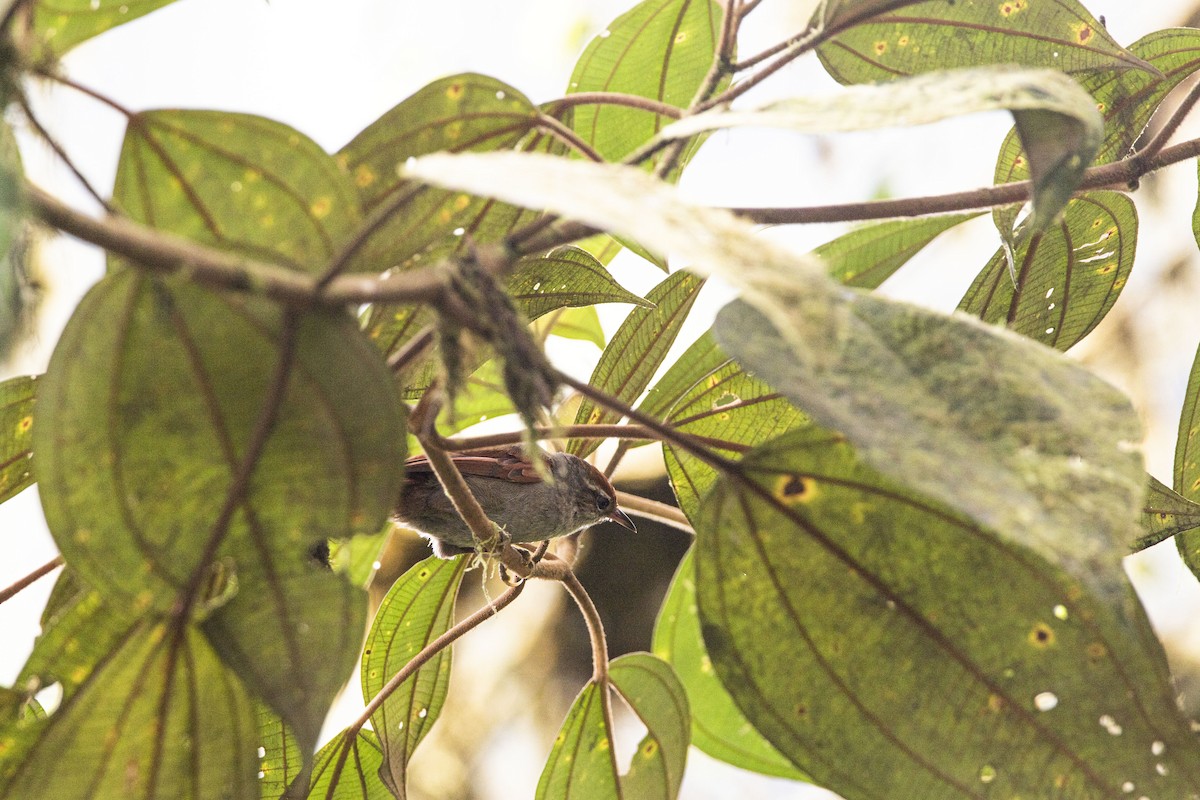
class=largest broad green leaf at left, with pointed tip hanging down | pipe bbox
[34,270,403,767]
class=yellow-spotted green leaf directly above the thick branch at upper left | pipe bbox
[109,110,360,272]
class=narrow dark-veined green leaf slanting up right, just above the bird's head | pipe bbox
[566,271,704,456]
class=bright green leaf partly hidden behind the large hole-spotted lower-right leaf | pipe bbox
[654,551,808,781]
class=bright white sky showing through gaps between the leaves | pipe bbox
[0,0,1200,798]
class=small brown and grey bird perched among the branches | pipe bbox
[394,446,636,558]
